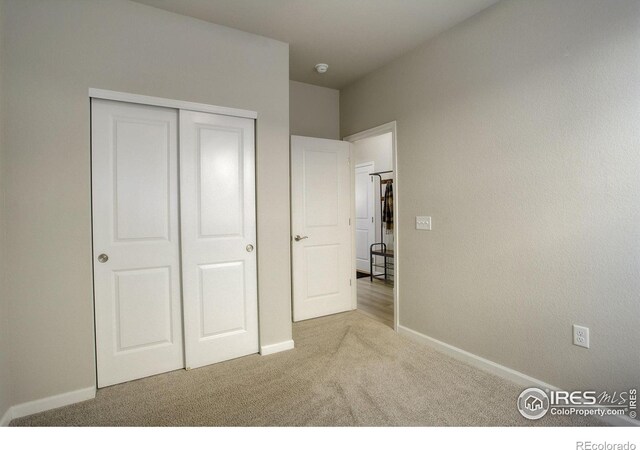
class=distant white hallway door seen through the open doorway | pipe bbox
[355,162,375,273]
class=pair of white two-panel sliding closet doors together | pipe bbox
[91,99,258,387]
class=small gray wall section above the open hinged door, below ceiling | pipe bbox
[289,81,340,139]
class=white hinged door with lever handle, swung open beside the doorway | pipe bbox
[291,136,354,321]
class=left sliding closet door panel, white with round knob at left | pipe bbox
[91,99,184,387]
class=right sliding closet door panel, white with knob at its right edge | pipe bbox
[180,110,258,368]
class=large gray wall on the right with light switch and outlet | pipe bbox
[341,0,640,390]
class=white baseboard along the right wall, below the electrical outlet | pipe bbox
[398,325,640,427]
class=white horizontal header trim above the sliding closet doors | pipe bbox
[89,88,258,119]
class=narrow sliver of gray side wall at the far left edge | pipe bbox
[0,1,11,418]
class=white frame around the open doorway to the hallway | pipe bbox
[342,120,400,332]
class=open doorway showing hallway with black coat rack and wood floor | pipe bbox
[345,122,398,329]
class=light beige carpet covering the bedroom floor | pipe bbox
[11,312,599,426]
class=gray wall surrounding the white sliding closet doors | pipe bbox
[2,0,291,403]
